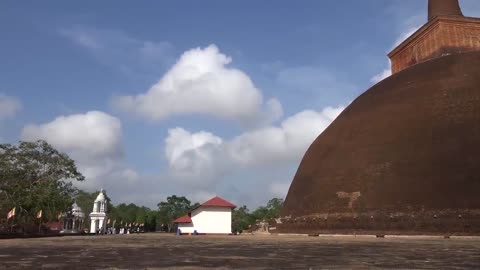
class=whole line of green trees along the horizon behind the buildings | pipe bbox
[0,140,283,232]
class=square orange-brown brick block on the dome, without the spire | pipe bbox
[389,17,480,73]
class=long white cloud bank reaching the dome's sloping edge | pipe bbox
[165,106,344,190]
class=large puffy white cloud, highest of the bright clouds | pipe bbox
[112,45,282,124]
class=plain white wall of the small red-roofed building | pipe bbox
[191,206,232,234]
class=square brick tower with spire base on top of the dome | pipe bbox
[388,0,480,74]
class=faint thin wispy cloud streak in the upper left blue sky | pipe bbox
[59,25,174,76]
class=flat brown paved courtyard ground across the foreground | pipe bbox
[0,233,480,269]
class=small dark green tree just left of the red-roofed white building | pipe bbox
[157,195,192,232]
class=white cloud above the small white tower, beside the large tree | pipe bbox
[21,111,139,190]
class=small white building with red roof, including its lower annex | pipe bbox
[174,196,236,234]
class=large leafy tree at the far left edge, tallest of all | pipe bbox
[0,140,85,229]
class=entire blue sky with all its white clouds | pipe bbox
[0,0,480,207]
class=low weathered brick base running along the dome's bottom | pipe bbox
[275,209,480,235]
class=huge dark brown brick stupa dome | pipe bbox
[279,0,480,234]
